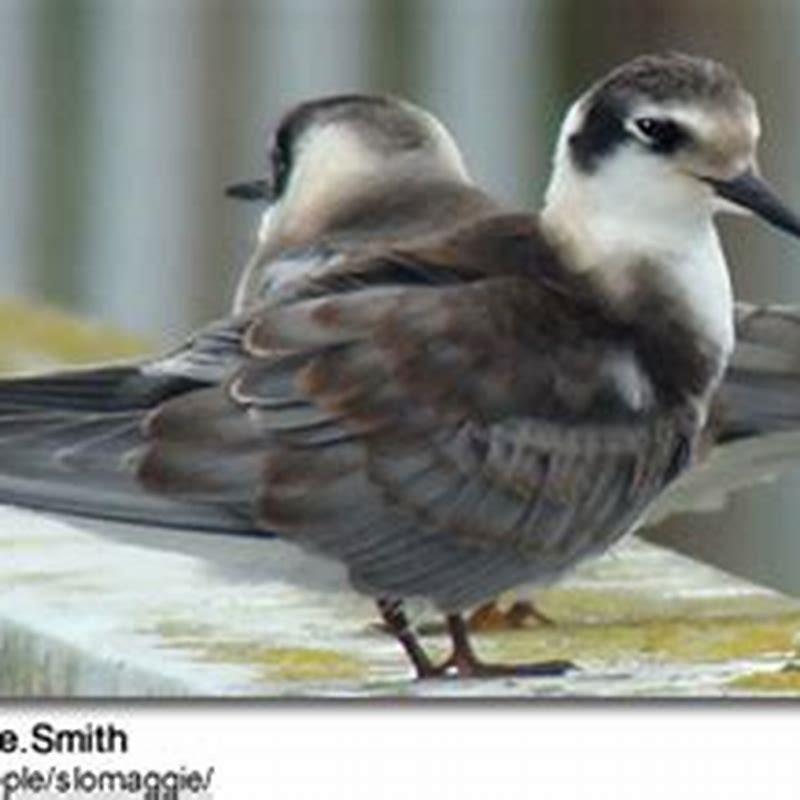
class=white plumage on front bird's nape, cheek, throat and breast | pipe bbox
[541,104,734,359]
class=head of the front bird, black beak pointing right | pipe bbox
[547,53,800,241]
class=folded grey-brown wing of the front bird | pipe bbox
[140,219,694,608]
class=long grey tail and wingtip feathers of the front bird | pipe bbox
[0,365,262,534]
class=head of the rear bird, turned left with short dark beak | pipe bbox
[228,94,470,241]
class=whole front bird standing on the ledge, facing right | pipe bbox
[0,55,800,677]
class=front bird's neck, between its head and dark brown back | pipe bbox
[541,170,734,394]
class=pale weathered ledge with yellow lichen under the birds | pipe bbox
[0,508,800,697]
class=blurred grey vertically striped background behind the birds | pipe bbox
[0,0,800,591]
